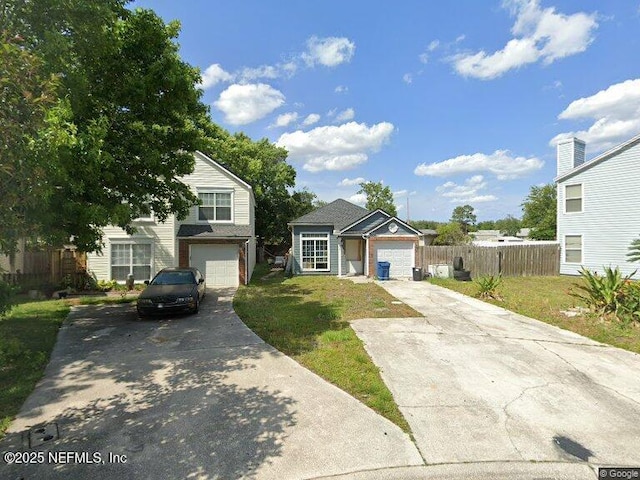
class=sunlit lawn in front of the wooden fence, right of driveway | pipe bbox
[429,276,640,353]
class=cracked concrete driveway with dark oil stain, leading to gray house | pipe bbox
[352,281,640,478]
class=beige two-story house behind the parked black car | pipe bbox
[87,152,256,287]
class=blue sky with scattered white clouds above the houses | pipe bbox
[133,0,640,221]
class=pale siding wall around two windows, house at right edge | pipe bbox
[557,138,640,275]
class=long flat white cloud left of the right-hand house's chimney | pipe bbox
[413,150,544,180]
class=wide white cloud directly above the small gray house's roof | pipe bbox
[276,122,394,172]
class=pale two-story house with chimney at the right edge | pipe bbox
[555,135,640,275]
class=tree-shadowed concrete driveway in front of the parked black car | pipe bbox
[0,291,423,479]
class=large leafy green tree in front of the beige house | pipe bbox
[0,0,207,251]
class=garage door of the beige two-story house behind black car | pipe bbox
[191,245,238,287]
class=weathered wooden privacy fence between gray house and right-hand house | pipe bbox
[416,244,560,278]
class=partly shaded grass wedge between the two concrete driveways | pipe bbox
[233,265,420,433]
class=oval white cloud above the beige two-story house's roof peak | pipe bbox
[214,83,285,125]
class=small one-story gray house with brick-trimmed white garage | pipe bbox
[288,199,424,278]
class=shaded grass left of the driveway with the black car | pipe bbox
[0,296,138,438]
